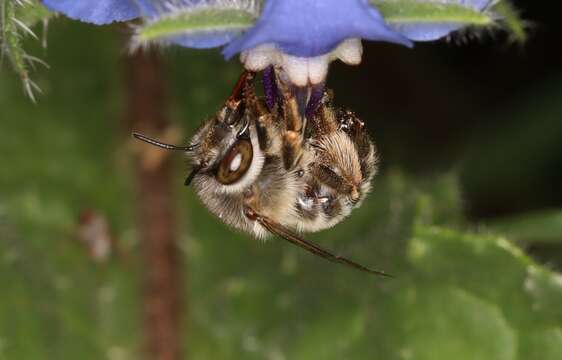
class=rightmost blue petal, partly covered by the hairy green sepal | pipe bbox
[390,0,493,41]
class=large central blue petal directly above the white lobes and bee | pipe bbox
[223,0,412,59]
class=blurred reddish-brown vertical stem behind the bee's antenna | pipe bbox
[125,51,181,360]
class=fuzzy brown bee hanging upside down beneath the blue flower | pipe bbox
[133,71,389,276]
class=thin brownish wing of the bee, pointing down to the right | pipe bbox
[256,216,392,277]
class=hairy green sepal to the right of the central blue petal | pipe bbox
[371,0,494,26]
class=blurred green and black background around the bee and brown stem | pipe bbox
[0,1,562,360]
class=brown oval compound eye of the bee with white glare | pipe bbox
[217,139,254,185]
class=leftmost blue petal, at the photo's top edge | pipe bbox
[43,0,140,25]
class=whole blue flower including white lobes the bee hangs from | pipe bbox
[43,0,494,86]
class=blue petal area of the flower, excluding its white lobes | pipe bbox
[43,0,493,52]
